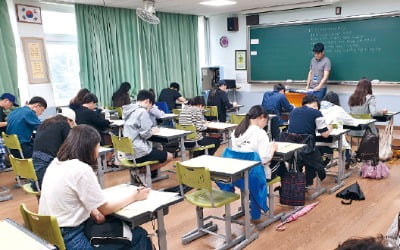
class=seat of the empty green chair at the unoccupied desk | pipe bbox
[186,189,240,208]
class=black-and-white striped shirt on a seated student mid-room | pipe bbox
[179,105,207,140]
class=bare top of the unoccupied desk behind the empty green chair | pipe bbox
[182,155,260,176]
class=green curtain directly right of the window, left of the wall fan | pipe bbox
[75,4,140,105]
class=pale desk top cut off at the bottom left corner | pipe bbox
[0,219,56,250]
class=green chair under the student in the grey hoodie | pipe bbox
[111,135,168,187]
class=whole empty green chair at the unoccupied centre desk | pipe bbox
[176,162,240,246]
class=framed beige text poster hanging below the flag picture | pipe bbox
[21,37,50,83]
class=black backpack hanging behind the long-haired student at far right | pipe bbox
[356,127,379,165]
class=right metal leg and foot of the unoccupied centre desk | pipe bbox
[234,170,258,249]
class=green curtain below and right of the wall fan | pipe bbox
[139,12,200,97]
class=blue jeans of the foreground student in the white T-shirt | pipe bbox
[61,223,153,250]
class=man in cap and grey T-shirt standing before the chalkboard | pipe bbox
[307,43,331,101]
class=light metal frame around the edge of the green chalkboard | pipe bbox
[246,11,400,85]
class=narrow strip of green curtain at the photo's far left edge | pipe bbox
[0,0,19,96]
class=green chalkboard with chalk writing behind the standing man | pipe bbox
[248,16,400,82]
